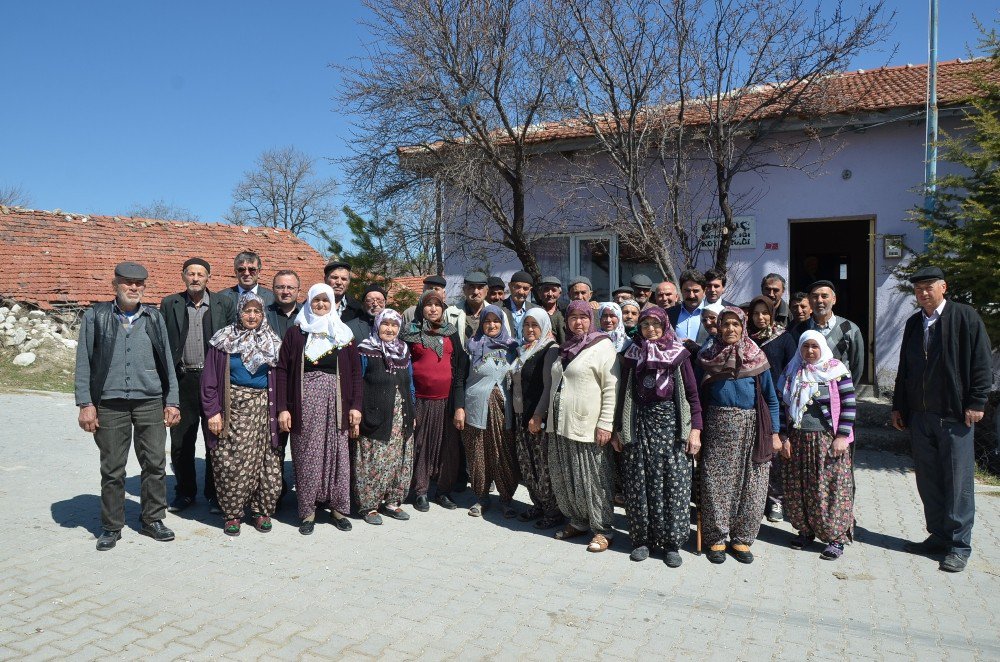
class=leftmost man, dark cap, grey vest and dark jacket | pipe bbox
[74,262,181,552]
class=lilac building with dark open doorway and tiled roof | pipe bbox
[436,59,996,387]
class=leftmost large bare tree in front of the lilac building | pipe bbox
[341,0,560,277]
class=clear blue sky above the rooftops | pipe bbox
[0,0,997,245]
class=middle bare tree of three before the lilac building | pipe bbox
[548,0,700,280]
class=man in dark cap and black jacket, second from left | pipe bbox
[160,257,236,513]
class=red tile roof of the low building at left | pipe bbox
[0,207,325,308]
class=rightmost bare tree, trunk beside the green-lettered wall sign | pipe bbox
[689,0,894,271]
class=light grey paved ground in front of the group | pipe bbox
[0,394,1000,661]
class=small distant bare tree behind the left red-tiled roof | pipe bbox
[225,147,338,237]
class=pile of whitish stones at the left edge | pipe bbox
[0,301,78,366]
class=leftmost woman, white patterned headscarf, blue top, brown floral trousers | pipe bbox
[201,292,281,536]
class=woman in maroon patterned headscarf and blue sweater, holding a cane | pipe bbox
[698,306,781,563]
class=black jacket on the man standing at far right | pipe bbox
[892,301,993,421]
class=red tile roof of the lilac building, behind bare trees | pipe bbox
[399,58,1000,156]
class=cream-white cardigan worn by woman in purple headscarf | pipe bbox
[547,338,619,443]
